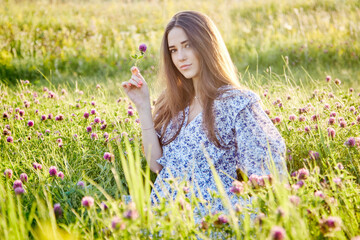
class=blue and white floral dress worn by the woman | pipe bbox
[151,85,287,222]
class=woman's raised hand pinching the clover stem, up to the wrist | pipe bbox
[121,67,150,111]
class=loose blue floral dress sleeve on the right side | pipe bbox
[233,93,287,179]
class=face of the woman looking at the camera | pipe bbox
[168,27,200,81]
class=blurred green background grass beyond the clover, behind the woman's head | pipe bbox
[0,0,360,88]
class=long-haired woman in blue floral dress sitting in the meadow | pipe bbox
[122,11,287,223]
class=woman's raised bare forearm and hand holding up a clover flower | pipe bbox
[122,67,163,173]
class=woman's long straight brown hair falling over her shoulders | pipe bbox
[153,11,240,147]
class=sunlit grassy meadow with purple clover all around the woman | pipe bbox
[0,0,360,239]
